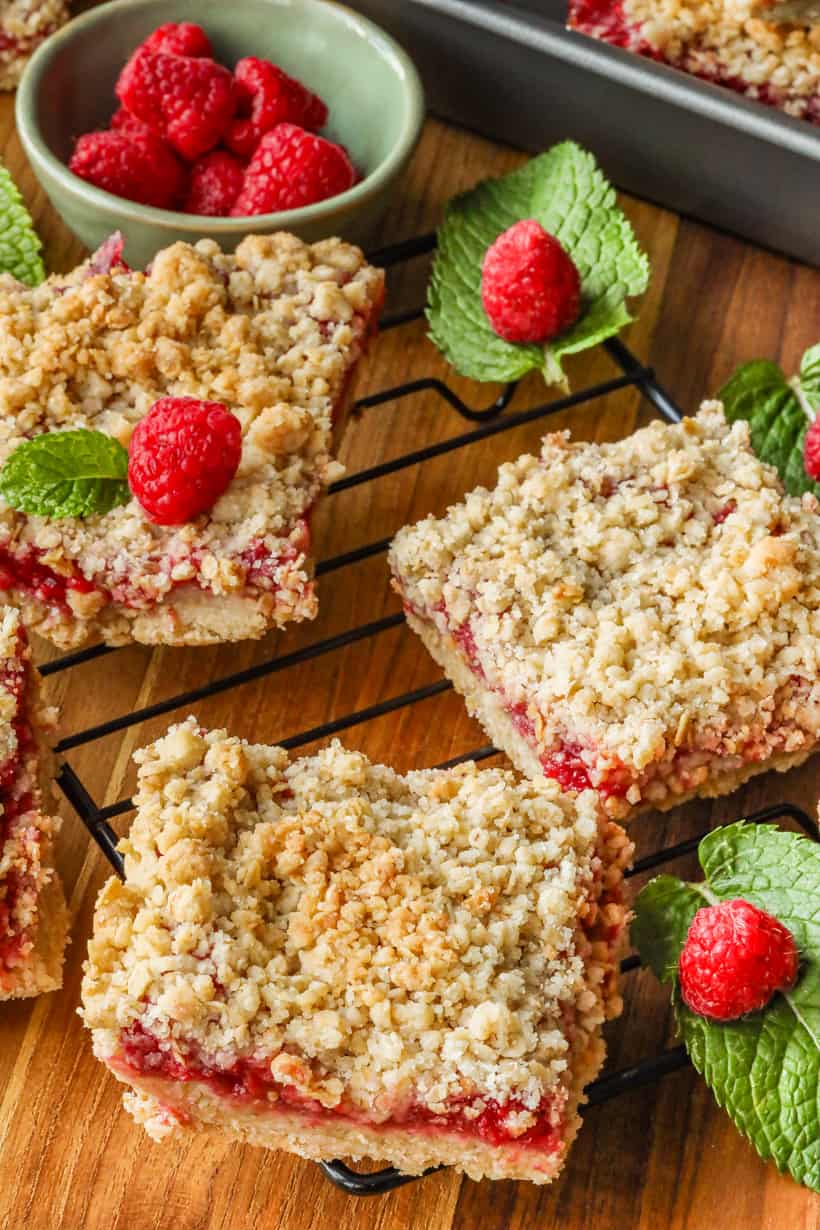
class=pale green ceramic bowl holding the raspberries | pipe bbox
[16,0,424,268]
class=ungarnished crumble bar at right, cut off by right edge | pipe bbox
[391,402,820,818]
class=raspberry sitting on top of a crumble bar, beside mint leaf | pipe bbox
[128,397,242,525]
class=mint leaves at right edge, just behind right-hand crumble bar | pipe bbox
[718,344,820,497]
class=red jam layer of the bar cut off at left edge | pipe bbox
[0,633,39,980]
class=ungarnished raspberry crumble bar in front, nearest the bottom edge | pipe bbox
[82,718,631,1183]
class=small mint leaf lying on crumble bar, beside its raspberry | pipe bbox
[0,428,130,517]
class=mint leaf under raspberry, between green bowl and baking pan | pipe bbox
[427,141,649,384]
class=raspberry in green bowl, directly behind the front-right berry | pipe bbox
[225,55,327,157]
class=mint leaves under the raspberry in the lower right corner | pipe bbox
[632,823,820,1192]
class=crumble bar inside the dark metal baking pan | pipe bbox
[569,0,820,124]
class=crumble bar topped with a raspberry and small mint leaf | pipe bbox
[0,234,384,648]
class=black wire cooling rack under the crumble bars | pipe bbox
[39,228,816,1196]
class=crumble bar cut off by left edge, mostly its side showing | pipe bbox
[0,608,68,1000]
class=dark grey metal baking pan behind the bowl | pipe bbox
[348,0,820,266]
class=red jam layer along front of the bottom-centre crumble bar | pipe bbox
[113,1021,563,1154]
